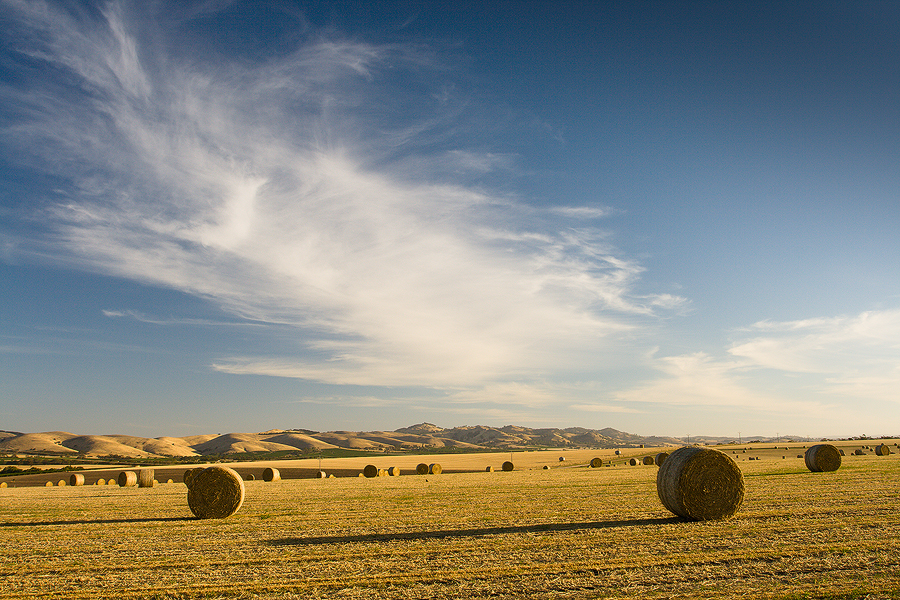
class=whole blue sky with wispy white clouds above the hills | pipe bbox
[0,0,900,438]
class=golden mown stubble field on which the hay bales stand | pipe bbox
[0,447,900,599]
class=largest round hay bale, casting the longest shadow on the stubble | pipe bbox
[656,446,744,521]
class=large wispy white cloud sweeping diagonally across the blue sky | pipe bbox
[4,1,685,402]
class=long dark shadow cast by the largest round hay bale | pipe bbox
[266,517,684,546]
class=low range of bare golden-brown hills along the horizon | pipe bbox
[0,423,696,458]
